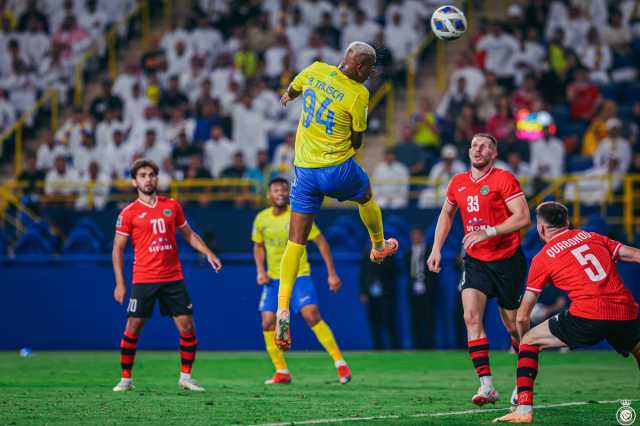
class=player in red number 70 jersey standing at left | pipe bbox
[113,160,222,392]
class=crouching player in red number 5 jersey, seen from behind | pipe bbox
[494,201,640,423]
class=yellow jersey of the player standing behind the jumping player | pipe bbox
[251,207,320,280]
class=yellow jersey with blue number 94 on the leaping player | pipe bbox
[291,62,369,168]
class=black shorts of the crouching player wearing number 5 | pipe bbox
[549,311,640,357]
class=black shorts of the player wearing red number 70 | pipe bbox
[127,281,193,318]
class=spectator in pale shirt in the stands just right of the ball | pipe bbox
[476,24,518,86]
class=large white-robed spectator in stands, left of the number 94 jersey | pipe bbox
[231,93,268,167]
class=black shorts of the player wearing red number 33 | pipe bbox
[459,249,527,310]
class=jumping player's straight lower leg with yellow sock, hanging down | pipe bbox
[275,211,313,350]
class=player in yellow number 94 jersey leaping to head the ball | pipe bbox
[275,41,398,350]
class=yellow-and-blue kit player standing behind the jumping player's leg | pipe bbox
[251,178,351,384]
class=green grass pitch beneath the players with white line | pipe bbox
[0,350,640,425]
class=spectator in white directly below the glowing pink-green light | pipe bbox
[531,113,565,180]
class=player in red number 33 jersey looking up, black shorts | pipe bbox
[427,133,531,406]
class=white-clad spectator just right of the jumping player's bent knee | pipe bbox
[373,147,409,209]
